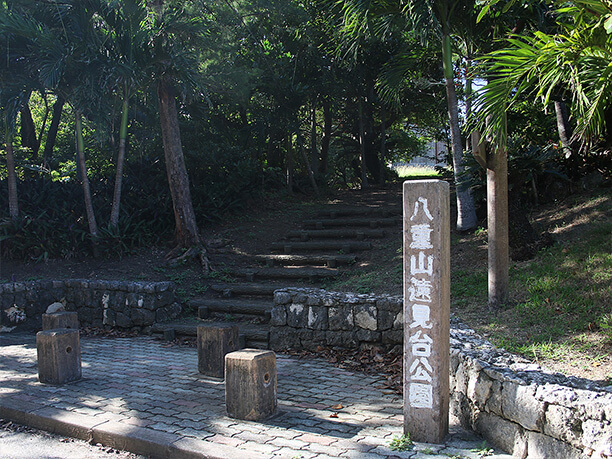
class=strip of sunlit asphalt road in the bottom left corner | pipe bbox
[0,419,146,459]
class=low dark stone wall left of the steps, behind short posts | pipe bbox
[0,279,182,332]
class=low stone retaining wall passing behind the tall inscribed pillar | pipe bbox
[270,289,612,459]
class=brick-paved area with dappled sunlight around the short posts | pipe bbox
[0,334,511,459]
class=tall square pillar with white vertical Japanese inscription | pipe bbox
[404,180,450,443]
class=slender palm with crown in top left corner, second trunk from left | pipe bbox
[0,0,104,243]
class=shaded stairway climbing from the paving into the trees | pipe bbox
[157,200,402,349]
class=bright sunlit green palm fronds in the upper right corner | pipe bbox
[477,0,612,146]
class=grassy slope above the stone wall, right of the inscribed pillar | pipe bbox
[451,192,612,373]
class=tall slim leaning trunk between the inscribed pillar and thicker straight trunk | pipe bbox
[442,33,478,231]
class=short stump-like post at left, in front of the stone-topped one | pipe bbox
[36,328,81,384]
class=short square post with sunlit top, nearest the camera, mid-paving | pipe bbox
[225,349,277,421]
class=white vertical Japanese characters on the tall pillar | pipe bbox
[406,197,434,408]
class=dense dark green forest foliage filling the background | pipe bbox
[0,0,612,259]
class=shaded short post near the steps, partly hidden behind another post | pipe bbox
[198,324,239,378]
